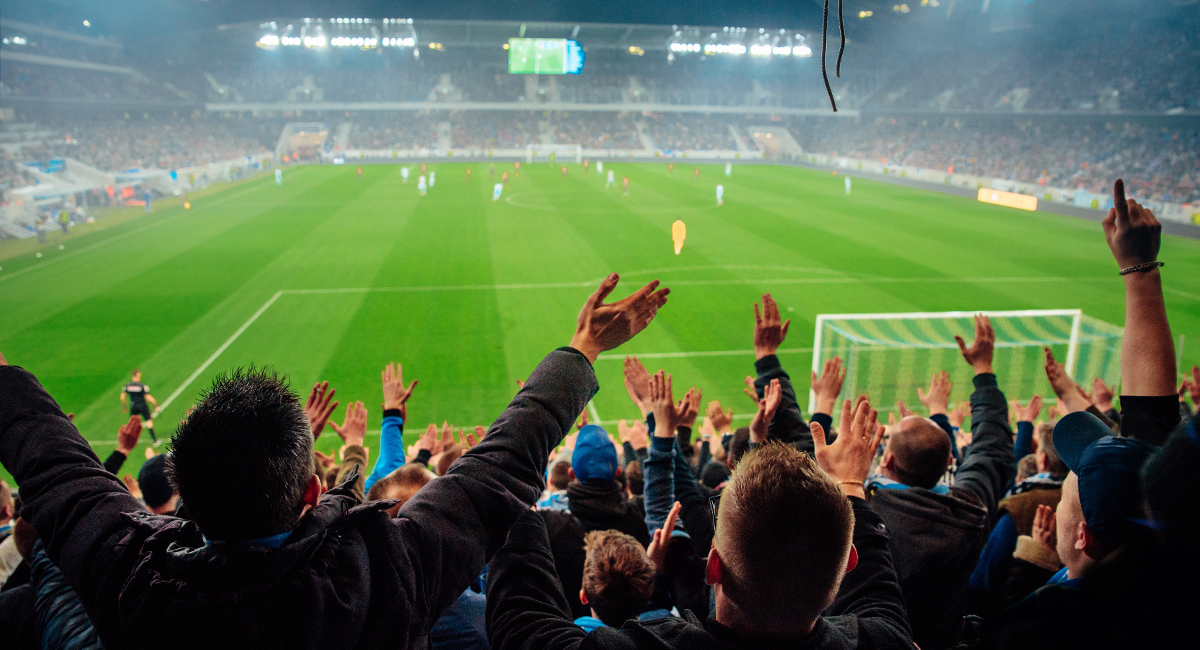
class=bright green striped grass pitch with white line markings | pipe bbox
[0,163,1200,482]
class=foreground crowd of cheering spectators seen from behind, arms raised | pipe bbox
[0,180,1200,650]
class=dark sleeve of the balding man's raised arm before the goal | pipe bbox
[954,373,1016,520]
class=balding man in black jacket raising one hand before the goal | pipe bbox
[869,315,1015,650]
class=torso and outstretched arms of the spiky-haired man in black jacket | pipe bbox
[0,273,667,649]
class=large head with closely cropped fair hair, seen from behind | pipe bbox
[707,443,857,636]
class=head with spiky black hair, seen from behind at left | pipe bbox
[167,367,320,541]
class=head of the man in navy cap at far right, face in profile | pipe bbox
[1054,411,1154,578]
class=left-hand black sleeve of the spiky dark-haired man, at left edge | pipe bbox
[0,366,145,648]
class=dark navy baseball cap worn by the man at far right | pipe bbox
[1054,411,1157,549]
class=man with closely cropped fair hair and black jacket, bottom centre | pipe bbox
[487,402,912,650]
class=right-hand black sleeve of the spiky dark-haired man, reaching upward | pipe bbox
[391,348,598,645]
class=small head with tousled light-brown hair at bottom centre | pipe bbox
[580,530,654,627]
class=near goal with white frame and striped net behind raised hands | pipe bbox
[809,309,1123,413]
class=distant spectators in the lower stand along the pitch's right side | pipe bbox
[792,119,1200,203]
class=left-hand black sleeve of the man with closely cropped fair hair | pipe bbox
[487,511,587,650]
